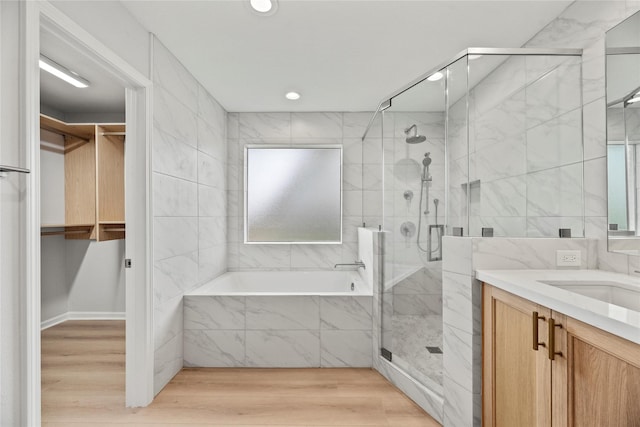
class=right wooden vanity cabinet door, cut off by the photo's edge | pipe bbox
[564,318,640,427]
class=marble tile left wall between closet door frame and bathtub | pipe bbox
[151,39,227,393]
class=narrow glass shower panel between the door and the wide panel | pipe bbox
[445,56,470,236]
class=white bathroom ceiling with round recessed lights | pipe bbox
[123,0,571,112]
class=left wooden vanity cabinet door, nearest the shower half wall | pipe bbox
[482,284,551,427]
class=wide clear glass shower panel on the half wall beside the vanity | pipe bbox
[468,55,584,237]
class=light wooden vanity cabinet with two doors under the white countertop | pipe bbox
[482,283,640,427]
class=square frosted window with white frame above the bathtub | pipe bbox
[244,145,342,244]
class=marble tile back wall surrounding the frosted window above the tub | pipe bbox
[226,112,382,271]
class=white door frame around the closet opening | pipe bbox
[19,1,154,426]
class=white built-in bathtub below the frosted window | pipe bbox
[186,271,373,296]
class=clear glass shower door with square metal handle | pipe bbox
[382,79,445,393]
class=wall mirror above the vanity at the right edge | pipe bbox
[606,12,640,255]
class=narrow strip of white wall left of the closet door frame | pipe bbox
[0,1,27,426]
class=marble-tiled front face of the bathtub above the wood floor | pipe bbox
[184,296,373,368]
